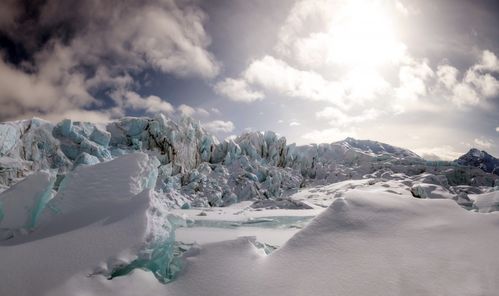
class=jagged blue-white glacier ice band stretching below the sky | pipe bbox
[0,114,499,207]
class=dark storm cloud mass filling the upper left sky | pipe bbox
[0,0,219,120]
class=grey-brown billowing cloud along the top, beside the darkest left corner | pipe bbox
[37,0,218,77]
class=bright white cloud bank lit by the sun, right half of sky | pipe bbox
[216,0,499,126]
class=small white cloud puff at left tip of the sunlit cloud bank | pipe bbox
[214,78,264,102]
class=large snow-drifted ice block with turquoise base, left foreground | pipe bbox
[0,153,185,295]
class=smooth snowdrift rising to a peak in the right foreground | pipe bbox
[47,189,499,296]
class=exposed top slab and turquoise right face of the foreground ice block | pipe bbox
[43,153,183,282]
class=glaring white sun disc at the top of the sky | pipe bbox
[327,0,405,68]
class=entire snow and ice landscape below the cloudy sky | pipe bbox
[0,117,499,296]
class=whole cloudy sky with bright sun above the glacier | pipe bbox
[0,0,499,159]
